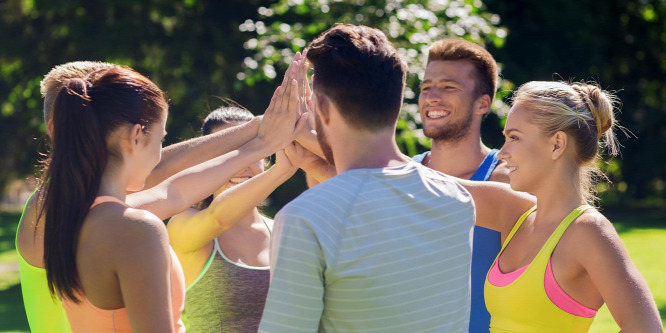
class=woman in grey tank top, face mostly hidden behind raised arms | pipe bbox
[167,106,296,333]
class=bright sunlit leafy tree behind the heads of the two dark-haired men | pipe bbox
[238,0,509,155]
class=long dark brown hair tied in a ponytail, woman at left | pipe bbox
[39,68,167,302]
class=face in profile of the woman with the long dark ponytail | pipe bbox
[127,110,168,191]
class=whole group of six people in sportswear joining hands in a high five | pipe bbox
[16,25,663,332]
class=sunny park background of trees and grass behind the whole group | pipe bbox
[0,0,666,332]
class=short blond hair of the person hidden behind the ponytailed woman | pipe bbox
[39,61,118,123]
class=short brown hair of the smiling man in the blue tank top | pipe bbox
[428,38,499,101]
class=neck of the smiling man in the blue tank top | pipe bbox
[423,129,490,178]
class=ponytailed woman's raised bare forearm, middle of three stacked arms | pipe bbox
[127,139,278,220]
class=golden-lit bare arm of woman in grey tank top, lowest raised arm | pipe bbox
[168,152,296,254]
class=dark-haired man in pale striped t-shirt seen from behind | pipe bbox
[259,25,474,332]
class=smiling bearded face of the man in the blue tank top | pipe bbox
[419,60,477,142]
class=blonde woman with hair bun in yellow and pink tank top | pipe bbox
[485,82,663,332]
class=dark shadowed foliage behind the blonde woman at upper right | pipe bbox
[485,0,666,204]
